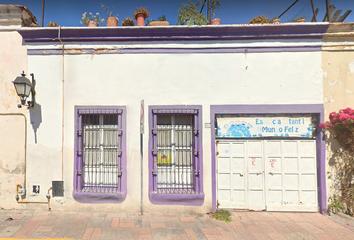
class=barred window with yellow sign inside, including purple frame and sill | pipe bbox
[149,106,204,205]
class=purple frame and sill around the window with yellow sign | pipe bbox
[148,105,204,206]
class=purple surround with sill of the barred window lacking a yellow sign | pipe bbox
[73,106,127,203]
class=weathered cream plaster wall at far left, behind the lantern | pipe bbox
[0,27,27,209]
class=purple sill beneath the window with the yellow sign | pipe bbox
[149,192,204,206]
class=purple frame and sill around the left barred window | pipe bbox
[73,106,127,203]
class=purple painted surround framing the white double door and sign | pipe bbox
[210,104,327,214]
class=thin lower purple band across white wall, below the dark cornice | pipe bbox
[27,45,321,55]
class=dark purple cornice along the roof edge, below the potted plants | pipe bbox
[18,23,329,43]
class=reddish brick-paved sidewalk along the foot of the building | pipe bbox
[0,210,354,240]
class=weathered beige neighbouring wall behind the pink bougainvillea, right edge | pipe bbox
[322,23,354,201]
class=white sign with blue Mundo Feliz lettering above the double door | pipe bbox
[217,115,313,138]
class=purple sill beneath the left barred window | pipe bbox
[73,192,127,204]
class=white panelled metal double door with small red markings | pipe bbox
[217,139,318,211]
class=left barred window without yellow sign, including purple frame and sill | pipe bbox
[74,106,126,203]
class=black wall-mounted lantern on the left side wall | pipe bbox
[13,71,36,108]
